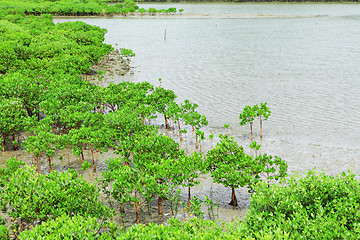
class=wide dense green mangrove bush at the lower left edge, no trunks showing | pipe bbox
[1,166,112,223]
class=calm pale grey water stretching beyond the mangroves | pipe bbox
[55,4,360,174]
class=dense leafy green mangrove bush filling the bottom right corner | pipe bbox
[245,171,360,239]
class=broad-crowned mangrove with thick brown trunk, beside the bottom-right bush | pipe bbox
[204,135,287,206]
